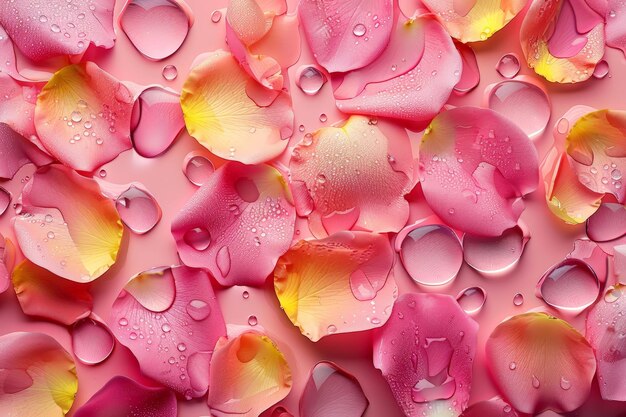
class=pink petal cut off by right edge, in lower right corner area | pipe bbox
[586,284,626,401]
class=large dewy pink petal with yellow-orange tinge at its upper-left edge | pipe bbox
[420,107,538,236]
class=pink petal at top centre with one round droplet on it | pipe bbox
[298,0,394,72]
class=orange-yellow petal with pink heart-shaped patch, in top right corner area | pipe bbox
[520,0,604,83]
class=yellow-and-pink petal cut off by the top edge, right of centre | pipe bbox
[423,0,526,43]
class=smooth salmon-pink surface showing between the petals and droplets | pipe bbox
[0,0,626,417]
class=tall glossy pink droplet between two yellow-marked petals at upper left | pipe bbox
[131,87,185,158]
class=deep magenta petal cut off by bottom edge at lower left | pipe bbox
[74,376,178,417]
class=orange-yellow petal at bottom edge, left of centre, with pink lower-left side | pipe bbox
[208,331,291,417]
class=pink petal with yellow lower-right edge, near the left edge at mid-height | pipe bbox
[14,165,124,282]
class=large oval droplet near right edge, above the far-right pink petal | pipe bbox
[537,258,600,312]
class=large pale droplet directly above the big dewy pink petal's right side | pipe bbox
[486,80,551,138]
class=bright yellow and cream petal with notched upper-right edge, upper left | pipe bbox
[181,51,293,164]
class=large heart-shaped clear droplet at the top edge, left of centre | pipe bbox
[118,0,193,61]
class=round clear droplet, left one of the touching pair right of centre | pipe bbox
[400,225,463,285]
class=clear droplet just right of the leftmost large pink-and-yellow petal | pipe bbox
[115,185,161,234]
